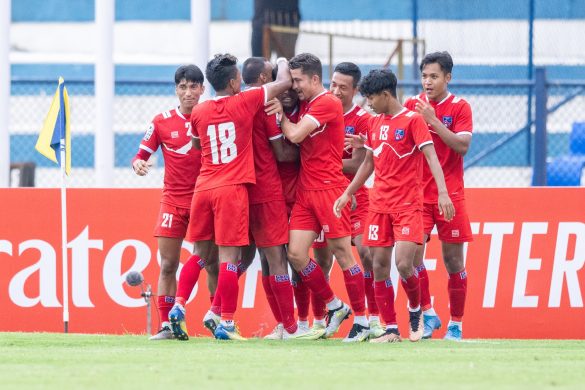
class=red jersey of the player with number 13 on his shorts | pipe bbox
[365,108,433,214]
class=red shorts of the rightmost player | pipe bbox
[423,199,473,244]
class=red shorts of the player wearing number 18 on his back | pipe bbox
[189,184,250,246]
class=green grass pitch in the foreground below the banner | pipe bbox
[0,333,585,389]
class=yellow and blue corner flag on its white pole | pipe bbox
[35,77,71,176]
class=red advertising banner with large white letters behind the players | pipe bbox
[0,188,585,339]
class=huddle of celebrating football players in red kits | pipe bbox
[132,52,472,342]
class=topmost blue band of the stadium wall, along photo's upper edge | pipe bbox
[12,0,585,22]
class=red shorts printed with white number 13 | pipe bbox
[363,210,424,247]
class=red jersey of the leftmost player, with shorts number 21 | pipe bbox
[140,108,201,209]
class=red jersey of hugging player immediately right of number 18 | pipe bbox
[248,110,284,204]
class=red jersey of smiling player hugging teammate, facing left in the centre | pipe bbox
[299,90,348,190]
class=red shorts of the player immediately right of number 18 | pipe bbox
[250,200,288,248]
